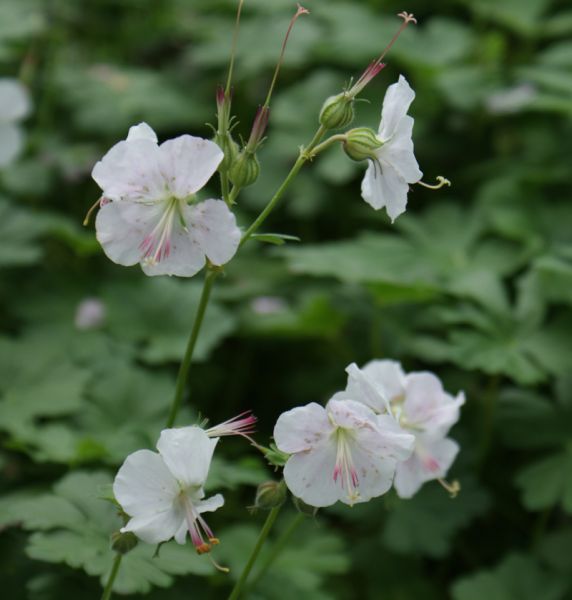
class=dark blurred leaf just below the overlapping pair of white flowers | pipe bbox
[383,479,490,558]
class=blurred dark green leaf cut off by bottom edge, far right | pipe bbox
[452,554,566,600]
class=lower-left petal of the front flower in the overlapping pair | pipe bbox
[284,440,340,507]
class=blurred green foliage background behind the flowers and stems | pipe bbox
[0,0,572,600]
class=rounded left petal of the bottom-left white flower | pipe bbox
[113,450,180,516]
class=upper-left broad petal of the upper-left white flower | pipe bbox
[91,138,169,202]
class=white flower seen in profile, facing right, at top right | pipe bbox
[361,75,423,221]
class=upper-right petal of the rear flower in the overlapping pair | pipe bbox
[403,372,465,436]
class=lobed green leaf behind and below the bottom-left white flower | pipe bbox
[0,471,213,594]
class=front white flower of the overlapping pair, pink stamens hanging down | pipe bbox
[274,399,414,506]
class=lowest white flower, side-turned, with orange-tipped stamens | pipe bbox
[113,426,224,554]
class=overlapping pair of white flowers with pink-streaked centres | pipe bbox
[274,360,464,507]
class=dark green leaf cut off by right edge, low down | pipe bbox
[515,447,572,513]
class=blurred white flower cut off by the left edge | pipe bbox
[0,78,31,167]
